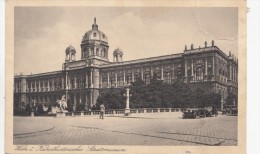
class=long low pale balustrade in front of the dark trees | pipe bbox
[55,108,184,116]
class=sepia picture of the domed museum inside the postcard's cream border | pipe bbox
[5,0,245,153]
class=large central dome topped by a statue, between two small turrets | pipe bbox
[81,18,108,44]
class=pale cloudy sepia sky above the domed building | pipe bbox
[14,7,238,74]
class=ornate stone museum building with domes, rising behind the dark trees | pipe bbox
[14,19,238,108]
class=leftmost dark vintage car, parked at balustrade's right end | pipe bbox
[182,108,206,119]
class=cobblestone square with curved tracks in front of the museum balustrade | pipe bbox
[14,113,237,146]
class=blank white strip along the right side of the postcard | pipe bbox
[247,0,260,154]
